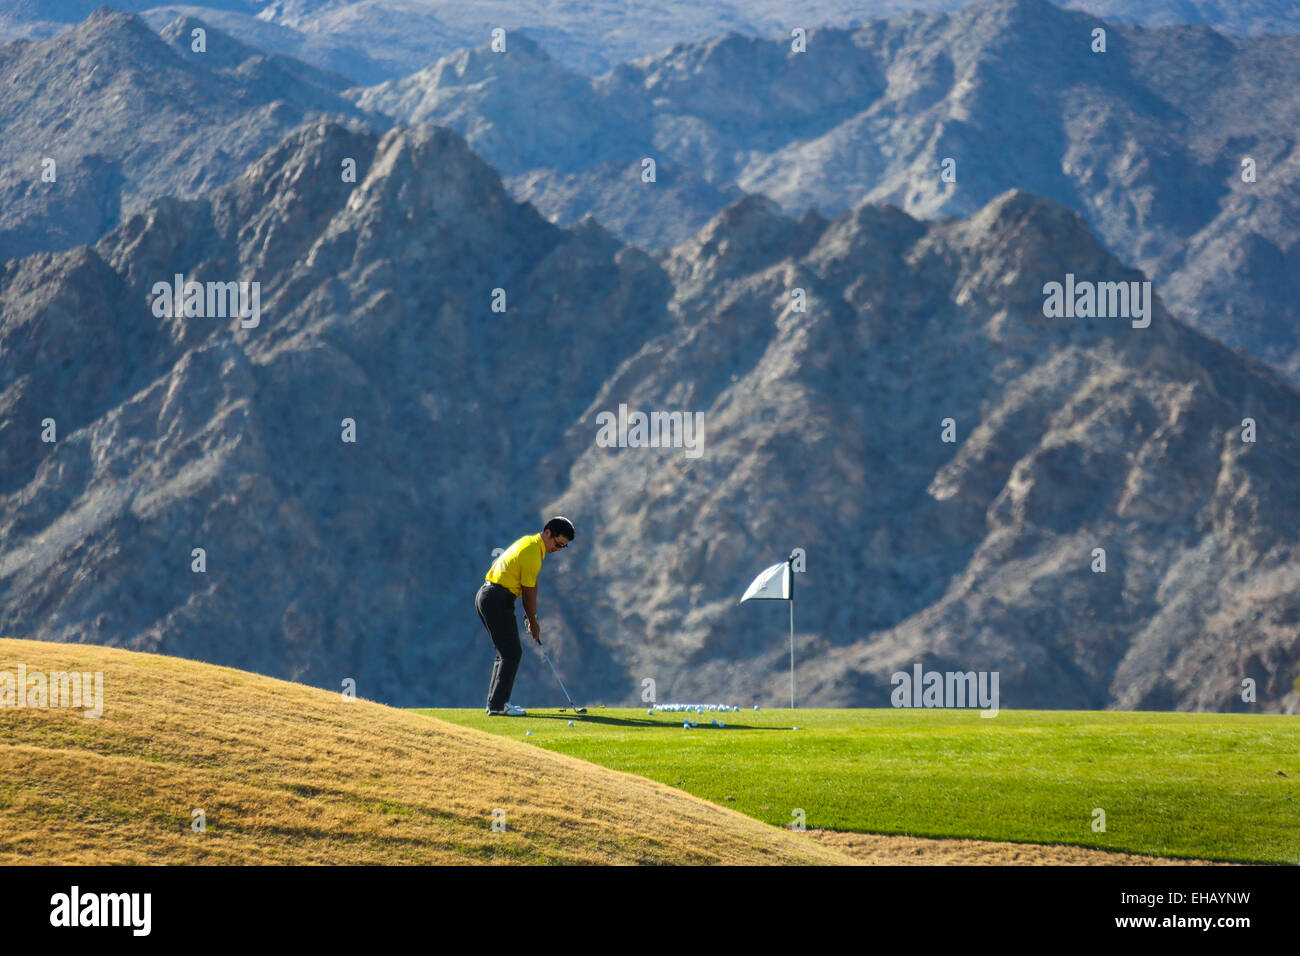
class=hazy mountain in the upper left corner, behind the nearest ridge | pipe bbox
[0,8,386,259]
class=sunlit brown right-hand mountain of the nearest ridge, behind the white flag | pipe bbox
[549,193,1300,710]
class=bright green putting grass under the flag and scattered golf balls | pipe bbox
[416,708,1300,864]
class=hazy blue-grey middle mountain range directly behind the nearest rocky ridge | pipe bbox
[10,0,1300,384]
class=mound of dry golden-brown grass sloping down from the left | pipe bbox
[0,640,853,864]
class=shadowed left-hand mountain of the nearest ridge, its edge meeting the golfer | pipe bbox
[0,124,667,702]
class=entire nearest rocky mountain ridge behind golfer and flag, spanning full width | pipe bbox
[0,122,1300,710]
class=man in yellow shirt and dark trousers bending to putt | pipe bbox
[475,516,573,717]
